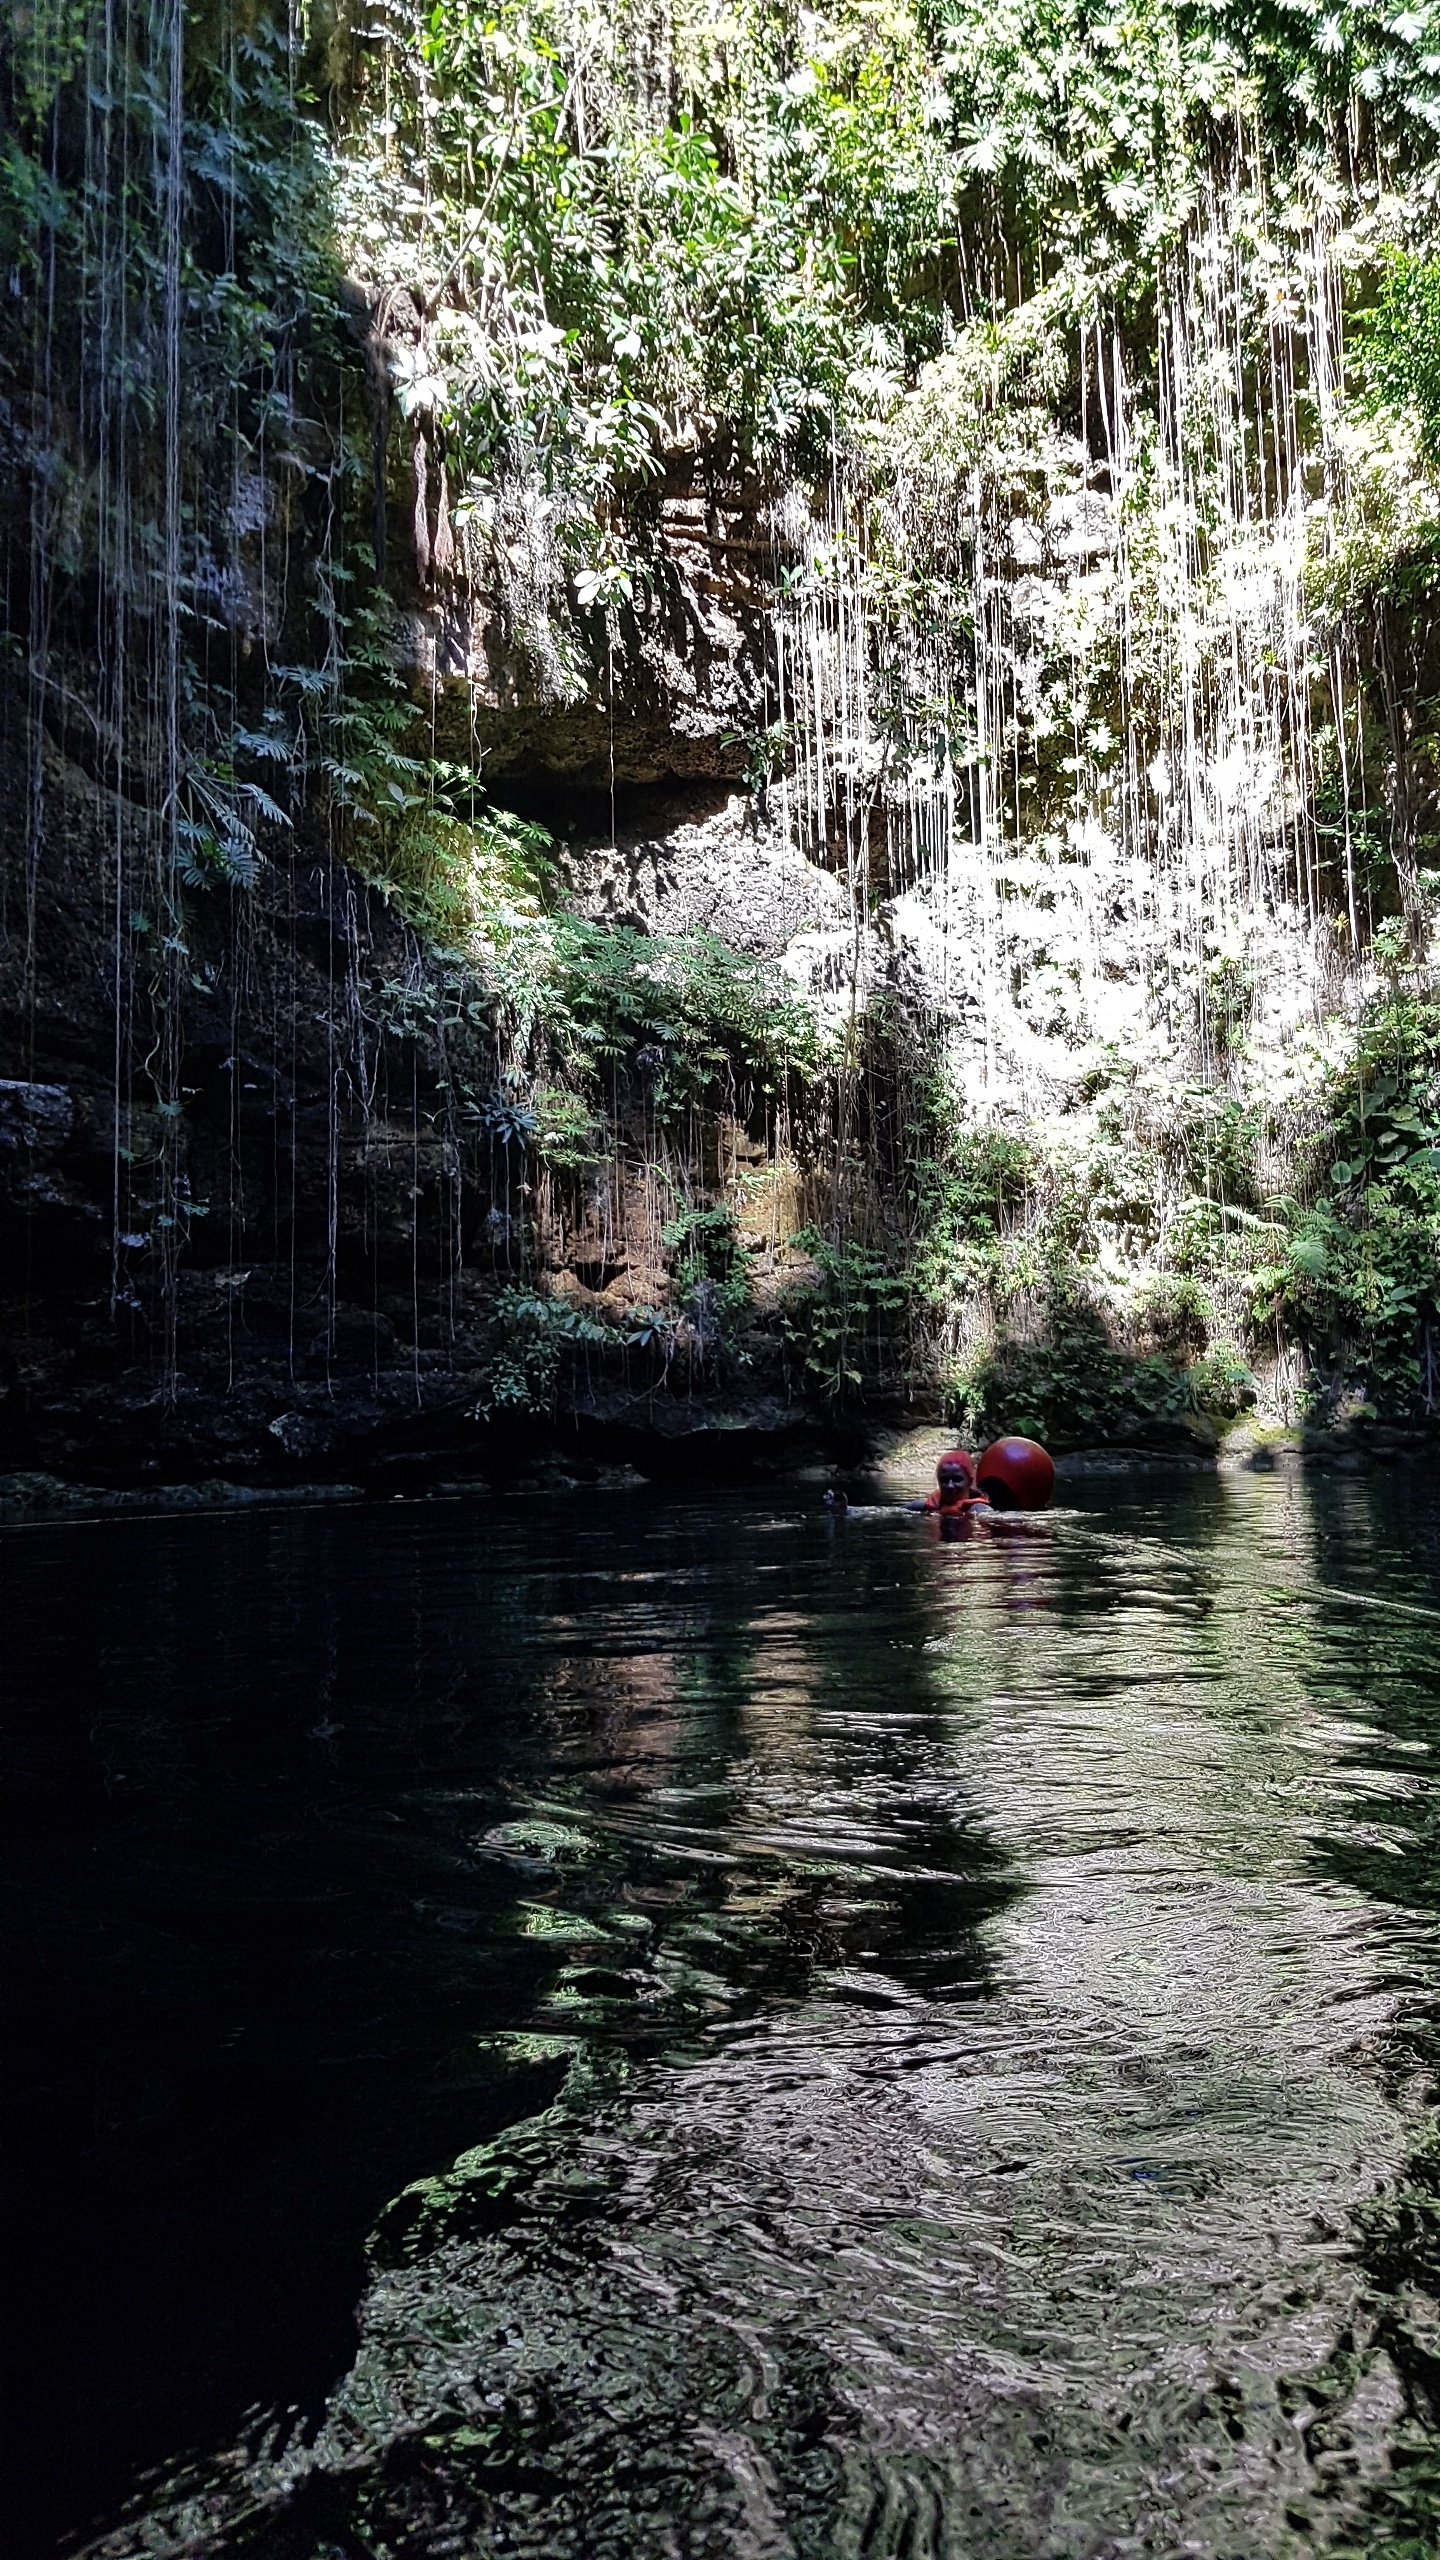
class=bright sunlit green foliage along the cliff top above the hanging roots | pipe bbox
[316,0,1440,555]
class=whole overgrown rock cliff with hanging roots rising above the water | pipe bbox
[0,0,1440,1482]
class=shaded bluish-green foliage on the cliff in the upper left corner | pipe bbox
[0,0,359,940]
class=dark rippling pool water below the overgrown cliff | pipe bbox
[0,1475,1440,2560]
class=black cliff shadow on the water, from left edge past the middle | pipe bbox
[0,1498,1010,2560]
